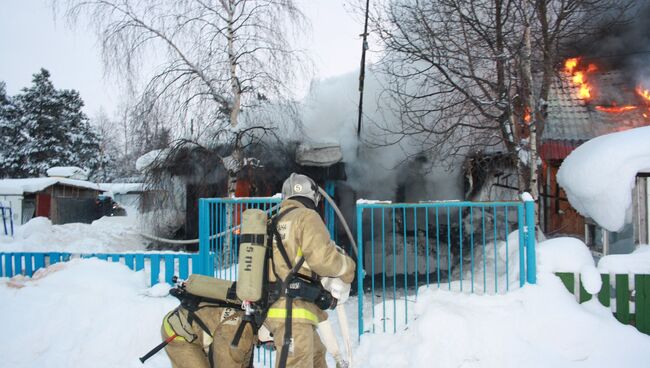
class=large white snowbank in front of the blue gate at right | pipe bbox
[355,234,650,368]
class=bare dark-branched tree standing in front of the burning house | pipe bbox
[364,0,629,216]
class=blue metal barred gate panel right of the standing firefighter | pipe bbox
[357,201,535,336]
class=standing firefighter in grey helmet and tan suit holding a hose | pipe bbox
[264,173,355,368]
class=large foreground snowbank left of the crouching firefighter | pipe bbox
[0,259,178,368]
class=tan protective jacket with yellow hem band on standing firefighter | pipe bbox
[267,199,355,325]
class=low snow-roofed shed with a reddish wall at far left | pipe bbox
[0,177,103,225]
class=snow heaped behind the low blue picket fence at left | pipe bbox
[0,216,148,253]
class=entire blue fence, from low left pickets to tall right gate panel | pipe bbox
[0,197,536,344]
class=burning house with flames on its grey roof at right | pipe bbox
[540,58,650,253]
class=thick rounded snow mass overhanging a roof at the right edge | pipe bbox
[557,127,650,231]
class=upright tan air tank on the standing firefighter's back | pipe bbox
[237,208,267,303]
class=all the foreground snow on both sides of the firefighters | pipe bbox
[0,231,650,368]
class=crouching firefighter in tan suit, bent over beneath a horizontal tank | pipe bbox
[162,303,255,368]
